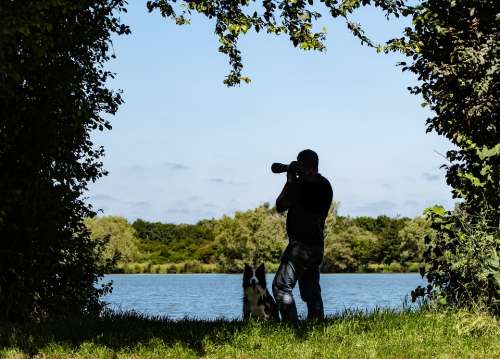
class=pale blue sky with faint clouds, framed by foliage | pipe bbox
[87,0,453,223]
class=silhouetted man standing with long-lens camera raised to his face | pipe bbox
[272,150,333,325]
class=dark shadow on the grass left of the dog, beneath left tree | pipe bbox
[0,312,232,355]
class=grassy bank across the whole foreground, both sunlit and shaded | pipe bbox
[0,311,500,359]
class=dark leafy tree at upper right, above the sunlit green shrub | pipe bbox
[388,0,500,225]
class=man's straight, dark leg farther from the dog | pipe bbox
[299,266,325,320]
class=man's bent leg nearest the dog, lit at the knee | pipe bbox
[273,260,299,325]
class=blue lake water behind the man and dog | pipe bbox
[104,273,425,319]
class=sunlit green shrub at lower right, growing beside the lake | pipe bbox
[412,207,500,313]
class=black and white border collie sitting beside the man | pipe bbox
[243,263,280,321]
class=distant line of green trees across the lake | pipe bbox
[86,204,432,273]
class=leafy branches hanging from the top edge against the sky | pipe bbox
[147,0,408,86]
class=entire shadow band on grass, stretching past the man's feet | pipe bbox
[0,311,415,356]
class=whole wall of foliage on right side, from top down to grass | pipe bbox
[388,0,500,312]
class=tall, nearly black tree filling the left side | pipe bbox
[0,0,129,320]
